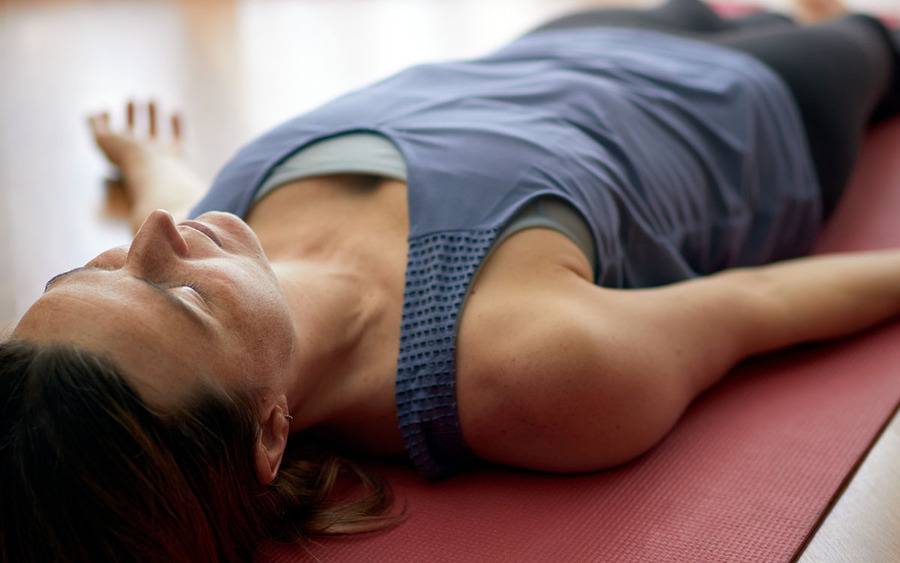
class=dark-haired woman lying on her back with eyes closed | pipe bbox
[0,0,900,562]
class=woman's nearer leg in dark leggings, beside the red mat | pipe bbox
[705,14,900,216]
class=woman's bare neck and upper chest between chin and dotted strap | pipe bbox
[241,175,408,446]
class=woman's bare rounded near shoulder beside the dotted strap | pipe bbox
[456,229,671,471]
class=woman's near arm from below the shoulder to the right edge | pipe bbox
[582,249,900,393]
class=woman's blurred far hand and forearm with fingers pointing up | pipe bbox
[89,101,207,232]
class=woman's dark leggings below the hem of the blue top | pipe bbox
[529,0,900,217]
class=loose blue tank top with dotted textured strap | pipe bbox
[191,27,822,478]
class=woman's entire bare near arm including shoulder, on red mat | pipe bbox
[457,249,900,472]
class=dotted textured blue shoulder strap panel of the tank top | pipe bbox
[396,229,499,479]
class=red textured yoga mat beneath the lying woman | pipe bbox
[260,8,900,563]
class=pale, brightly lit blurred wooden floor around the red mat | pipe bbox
[0,0,900,562]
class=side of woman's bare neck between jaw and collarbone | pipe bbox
[272,260,387,431]
